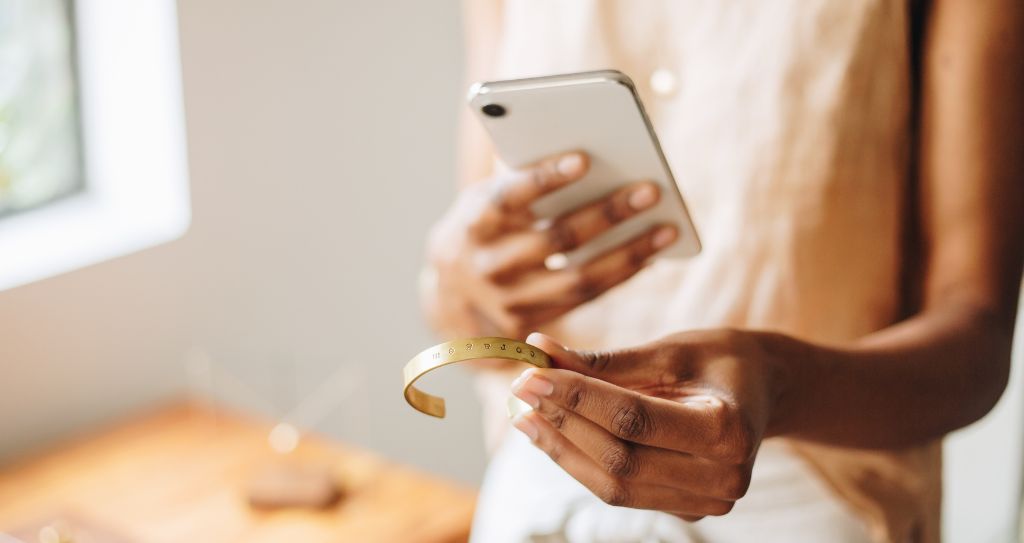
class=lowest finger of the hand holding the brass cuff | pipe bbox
[513,412,732,516]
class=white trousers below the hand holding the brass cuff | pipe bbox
[470,429,870,543]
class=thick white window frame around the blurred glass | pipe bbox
[0,0,190,290]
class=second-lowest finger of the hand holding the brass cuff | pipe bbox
[513,389,750,501]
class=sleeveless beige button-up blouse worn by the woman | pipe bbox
[471,0,941,542]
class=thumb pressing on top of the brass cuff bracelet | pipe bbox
[526,332,659,386]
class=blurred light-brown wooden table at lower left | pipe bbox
[0,404,475,543]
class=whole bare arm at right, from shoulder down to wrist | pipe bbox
[780,0,1024,448]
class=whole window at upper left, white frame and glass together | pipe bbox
[0,0,189,290]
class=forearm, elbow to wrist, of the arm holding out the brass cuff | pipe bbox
[770,297,1013,448]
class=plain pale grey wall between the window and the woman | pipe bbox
[0,0,484,481]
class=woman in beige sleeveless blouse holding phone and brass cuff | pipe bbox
[424,0,1024,543]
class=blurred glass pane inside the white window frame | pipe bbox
[0,0,84,217]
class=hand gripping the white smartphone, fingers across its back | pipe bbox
[423,153,677,338]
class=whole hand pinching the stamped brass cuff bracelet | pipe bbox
[512,330,792,520]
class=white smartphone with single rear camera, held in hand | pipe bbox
[469,70,700,263]
